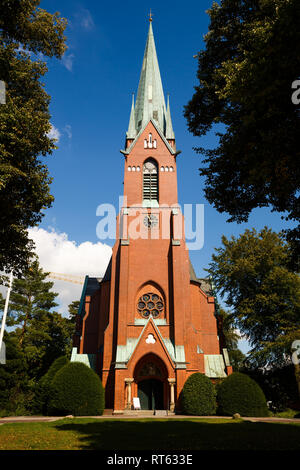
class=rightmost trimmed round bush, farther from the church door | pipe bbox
[217,372,268,416]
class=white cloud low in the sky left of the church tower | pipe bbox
[29,227,112,313]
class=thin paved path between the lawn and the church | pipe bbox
[0,413,300,425]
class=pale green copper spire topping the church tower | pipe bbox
[127,20,175,139]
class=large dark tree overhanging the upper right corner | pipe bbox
[185,0,300,268]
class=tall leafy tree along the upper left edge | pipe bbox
[0,0,66,274]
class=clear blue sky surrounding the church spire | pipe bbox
[34,0,296,352]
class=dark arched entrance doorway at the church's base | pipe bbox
[138,379,164,410]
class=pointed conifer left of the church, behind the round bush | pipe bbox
[0,258,79,415]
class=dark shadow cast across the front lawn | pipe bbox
[55,418,300,451]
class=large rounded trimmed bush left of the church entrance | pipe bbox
[48,362,104,416]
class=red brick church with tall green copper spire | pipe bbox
[71,19,231,413]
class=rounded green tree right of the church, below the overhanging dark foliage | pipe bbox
[208,227,300,367]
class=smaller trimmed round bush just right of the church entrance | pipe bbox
[181,372,216,416]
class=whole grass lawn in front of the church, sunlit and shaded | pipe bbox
[0,418,300,451]
